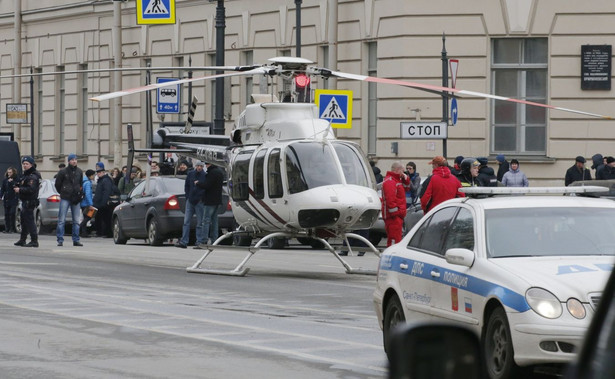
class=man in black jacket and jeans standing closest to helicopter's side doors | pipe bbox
[196,163,224,244]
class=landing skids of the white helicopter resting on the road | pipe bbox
[186,230,381,276]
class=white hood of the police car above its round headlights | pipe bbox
[490,256,615,302]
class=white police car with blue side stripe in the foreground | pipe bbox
[374,186,615,378]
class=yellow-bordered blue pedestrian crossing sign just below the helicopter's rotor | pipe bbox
[314,89,352,129]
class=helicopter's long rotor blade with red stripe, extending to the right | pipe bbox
[321,70,613,120]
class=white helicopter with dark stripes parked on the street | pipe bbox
[91,57,609,276]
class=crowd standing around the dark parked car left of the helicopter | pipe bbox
[0,154,224,251]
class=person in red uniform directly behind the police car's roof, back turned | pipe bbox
[421,155,465,214]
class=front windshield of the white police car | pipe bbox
[485,207,615,258]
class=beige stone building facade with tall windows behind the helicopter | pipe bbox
[0,0,615,185]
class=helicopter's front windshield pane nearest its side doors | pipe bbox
[286,142,342,193]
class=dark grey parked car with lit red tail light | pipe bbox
[112,176,228,246]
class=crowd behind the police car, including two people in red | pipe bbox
[370,154,615,246]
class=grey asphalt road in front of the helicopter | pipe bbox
[0,234,387,379]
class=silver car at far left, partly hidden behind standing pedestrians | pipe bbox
[15,179,73,233]
